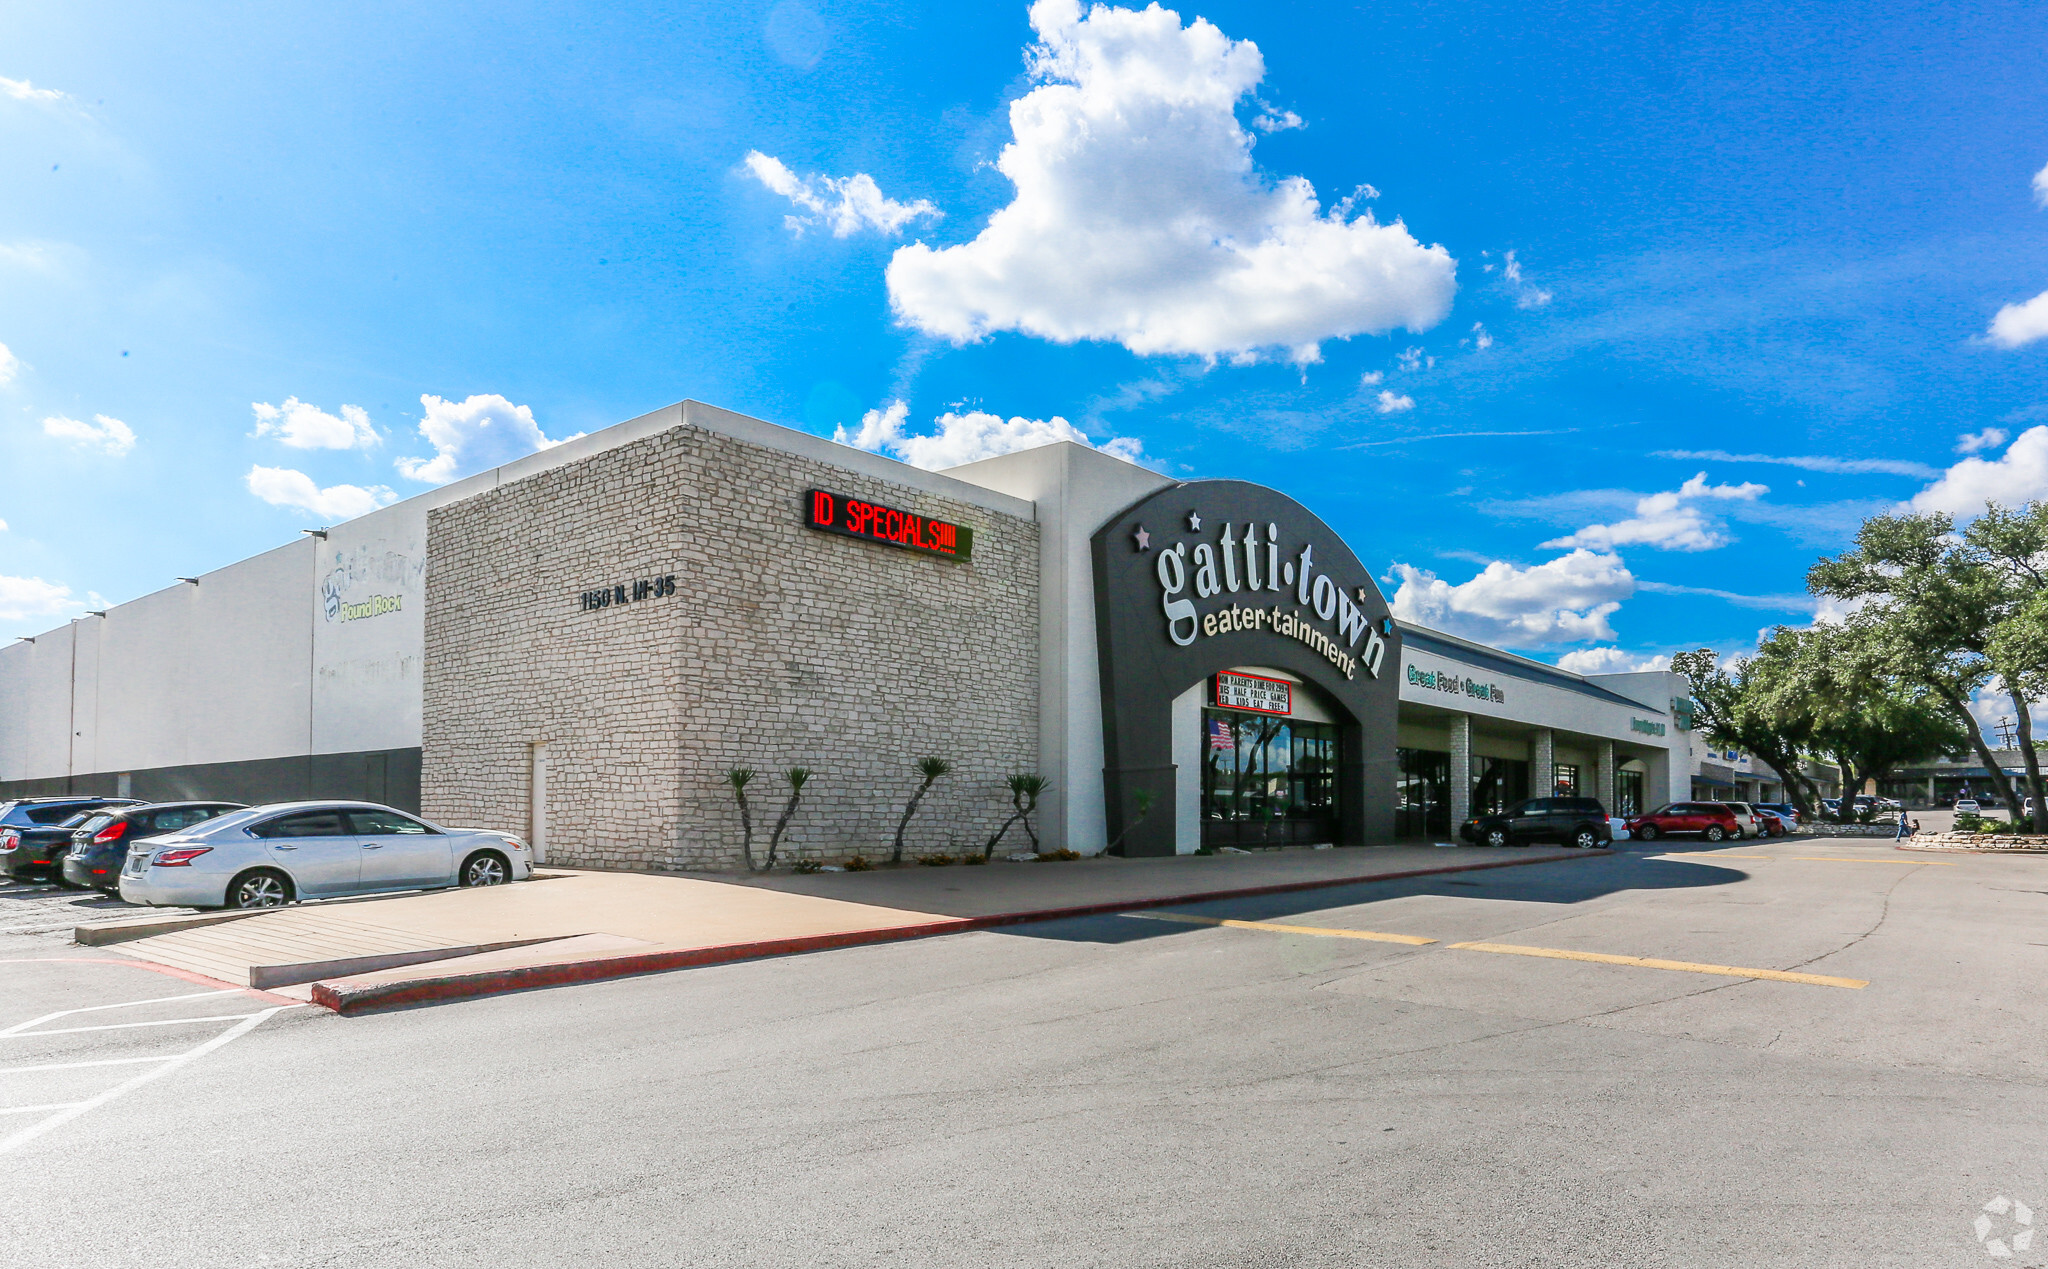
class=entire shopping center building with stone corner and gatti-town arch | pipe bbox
[0,401,1696,870]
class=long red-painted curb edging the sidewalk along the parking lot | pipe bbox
[313,849,1614,1015]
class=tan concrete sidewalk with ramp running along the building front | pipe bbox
[92,845,1606,1013]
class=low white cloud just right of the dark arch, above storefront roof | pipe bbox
[1391,551,1636,647]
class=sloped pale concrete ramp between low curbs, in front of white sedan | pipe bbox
[117,909,577,989]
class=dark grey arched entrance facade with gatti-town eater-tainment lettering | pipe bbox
[1092,481,1401,856]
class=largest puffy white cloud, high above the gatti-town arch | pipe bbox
[889,0,1456,364]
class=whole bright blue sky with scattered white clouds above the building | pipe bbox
[0,0,2048,667]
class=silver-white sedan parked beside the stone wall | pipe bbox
[121,802,532,907]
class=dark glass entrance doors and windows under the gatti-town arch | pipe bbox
[1202,710,1337,847]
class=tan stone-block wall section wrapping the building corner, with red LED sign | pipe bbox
[422,426,1038,870]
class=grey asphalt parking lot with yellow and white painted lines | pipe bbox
[0,839,2048,1269]
